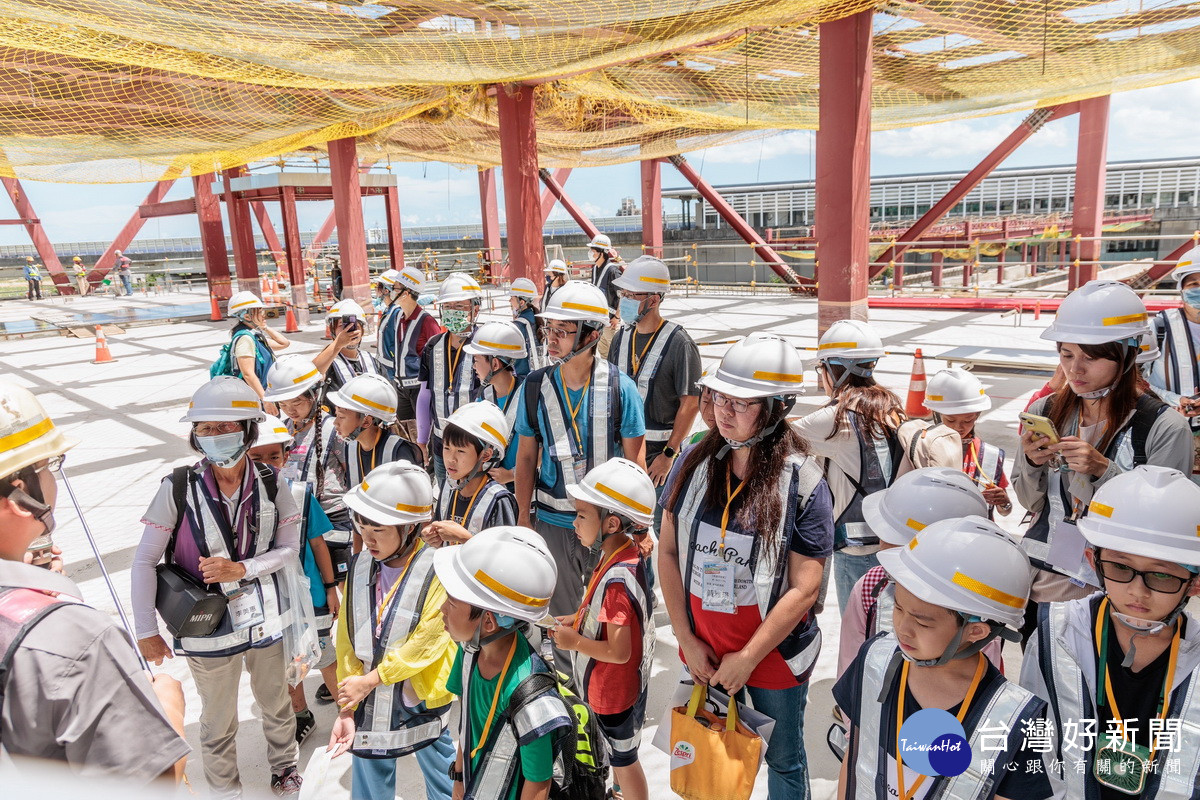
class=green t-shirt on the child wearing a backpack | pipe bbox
[446,634,554,800]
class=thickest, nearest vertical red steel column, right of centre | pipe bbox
[816,11,872,333]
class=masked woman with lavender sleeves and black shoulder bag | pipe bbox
[126,375,302,798]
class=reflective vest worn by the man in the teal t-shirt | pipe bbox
[522,359,622,513]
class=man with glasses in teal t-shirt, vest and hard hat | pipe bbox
[516,281,653,615]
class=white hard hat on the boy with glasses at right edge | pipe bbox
[1078,465,1200,566]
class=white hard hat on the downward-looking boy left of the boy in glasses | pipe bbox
[878,516,1033,628]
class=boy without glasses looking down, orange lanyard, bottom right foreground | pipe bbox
[833,517,1054,800]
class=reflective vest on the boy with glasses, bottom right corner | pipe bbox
[1022,594,1200,800]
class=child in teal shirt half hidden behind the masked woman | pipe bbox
[248,417,341,744]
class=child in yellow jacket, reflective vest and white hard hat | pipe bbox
[329,462,456,800]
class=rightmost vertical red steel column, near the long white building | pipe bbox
[1070,95,1109,289]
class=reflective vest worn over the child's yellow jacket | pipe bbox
[346,542,450,758]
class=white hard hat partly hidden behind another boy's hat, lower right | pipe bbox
[863,467,988,546]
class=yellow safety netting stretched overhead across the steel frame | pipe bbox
[0,0,1200,182]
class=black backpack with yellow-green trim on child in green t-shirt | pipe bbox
[506,667,608,800]
